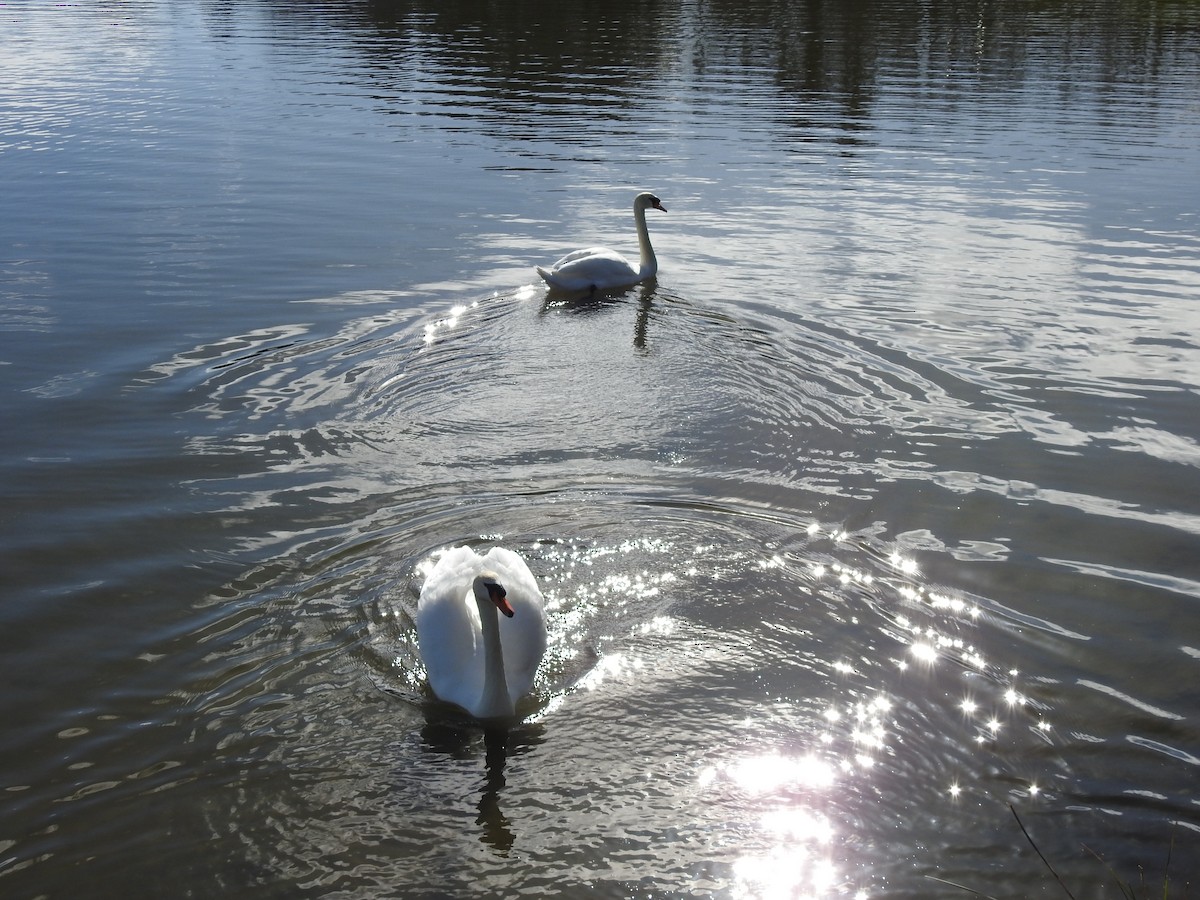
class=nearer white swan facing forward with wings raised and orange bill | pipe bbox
[416,547,546,719]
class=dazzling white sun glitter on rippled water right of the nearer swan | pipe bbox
[547,524,1052,900]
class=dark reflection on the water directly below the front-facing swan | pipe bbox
[421,710,544,856]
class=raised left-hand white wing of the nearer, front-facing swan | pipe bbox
[416,547,484,709]
